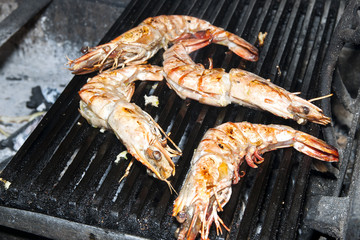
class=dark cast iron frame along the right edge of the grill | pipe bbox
[306,0,360,239]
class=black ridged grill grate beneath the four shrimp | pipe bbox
[0,0,344,239]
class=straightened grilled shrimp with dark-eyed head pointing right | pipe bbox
[163,38,331,125]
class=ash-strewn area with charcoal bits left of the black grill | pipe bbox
[0,0,127,176]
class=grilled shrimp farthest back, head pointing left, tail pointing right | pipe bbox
[68,15,258,74]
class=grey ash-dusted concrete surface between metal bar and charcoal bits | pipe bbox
[0,0,130,167]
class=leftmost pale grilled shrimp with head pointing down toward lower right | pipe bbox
[79,65,181,187]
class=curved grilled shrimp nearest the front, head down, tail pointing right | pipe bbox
[173,122,339,239]
